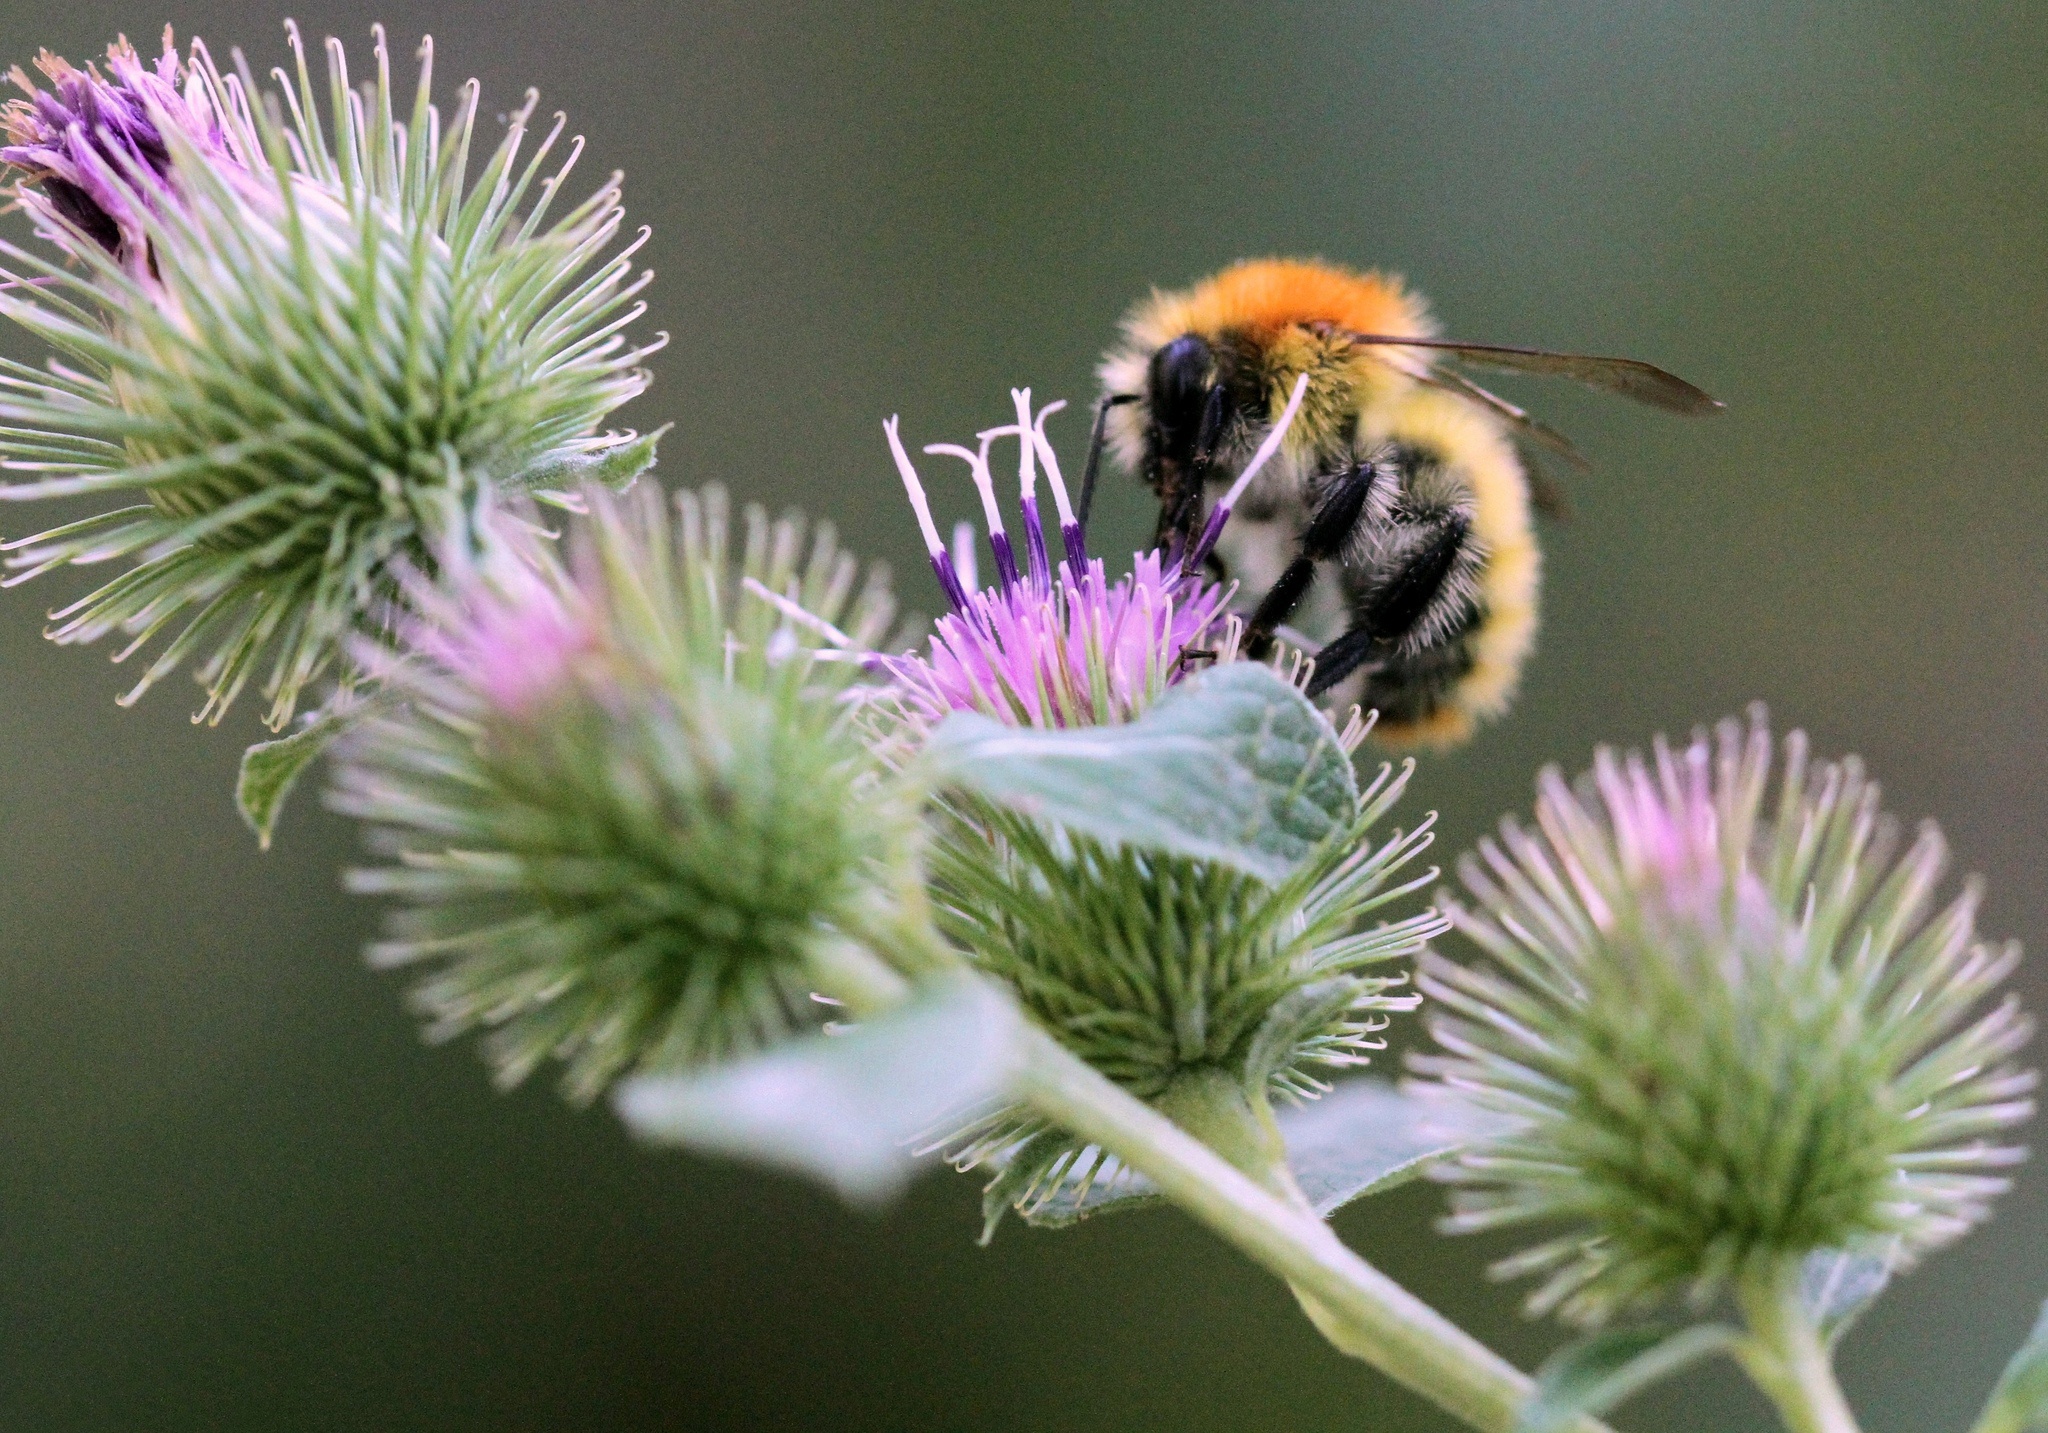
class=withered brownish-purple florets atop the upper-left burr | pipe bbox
[0,27,242,266]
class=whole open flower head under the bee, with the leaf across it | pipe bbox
[868,387,1442,1226]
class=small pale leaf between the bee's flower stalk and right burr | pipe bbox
[1276,1079,1513,1218]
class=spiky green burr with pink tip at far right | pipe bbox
[1417,710,2034,1325]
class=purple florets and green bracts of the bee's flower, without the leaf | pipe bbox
[868,387,1444,1228]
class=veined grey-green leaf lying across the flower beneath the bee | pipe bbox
[926,661,1358,882]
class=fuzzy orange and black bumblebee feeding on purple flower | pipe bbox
[1081,260,1720,747]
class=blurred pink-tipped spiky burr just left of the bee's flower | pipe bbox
[332,483,918,1099]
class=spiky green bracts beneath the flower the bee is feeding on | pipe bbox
[932,749,1444,1228]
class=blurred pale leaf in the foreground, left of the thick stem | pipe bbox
[612,976,1022,1204]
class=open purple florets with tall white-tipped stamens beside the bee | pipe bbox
[868,389,1298,737]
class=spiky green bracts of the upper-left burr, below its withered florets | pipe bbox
[0,31,657,727]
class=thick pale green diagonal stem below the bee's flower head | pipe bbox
[1024,1028,1604,1433]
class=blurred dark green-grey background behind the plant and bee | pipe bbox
[0,0,2048,1433]
